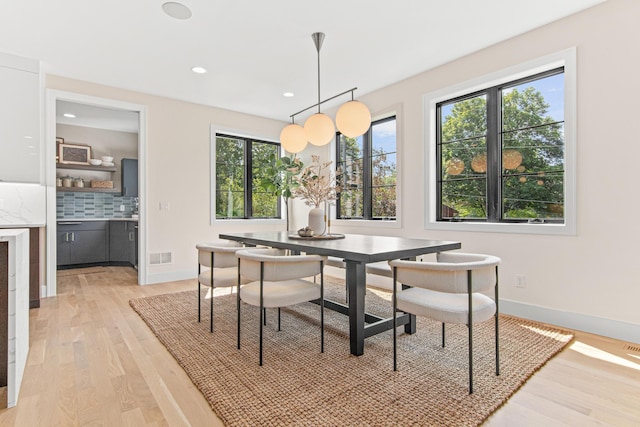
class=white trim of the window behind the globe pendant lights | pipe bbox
[330,104,403,228]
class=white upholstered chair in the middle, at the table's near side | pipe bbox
[236,249,326,366]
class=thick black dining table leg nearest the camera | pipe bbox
[346,260,367,356]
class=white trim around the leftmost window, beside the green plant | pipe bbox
[209,125,287,226]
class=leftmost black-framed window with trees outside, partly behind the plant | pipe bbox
[215,134,280,219]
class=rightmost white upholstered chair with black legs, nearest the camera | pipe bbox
[389,252,500,394]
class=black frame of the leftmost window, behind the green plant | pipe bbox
[213,132,282,221]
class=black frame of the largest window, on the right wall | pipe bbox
[435,66,567,224]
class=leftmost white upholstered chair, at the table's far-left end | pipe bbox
[196,240,243,332]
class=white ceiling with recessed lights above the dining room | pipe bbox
[0,0,604,129]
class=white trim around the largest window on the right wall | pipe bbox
[423,47,576,235]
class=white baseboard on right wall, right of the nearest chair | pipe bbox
[500,299,640,344]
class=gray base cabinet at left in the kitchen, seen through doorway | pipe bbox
[57,221,109,266]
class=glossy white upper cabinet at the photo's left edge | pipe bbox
[0,53,43,183]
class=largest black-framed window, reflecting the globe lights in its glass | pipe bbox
[436,67,565,223]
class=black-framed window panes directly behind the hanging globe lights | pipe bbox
[336,116,397,220]
